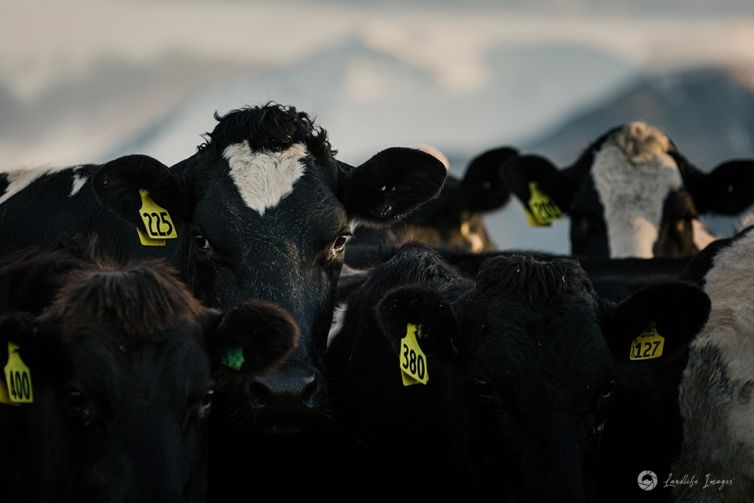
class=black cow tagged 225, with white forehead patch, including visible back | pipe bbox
[0,104,446,434]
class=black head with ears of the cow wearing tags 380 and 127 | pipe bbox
[379,250,709,501]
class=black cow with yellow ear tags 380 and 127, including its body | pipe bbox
[328,244,709,502]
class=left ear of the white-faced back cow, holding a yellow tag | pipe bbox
[503,155,574,220]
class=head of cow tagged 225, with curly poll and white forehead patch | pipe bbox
[95,104,446,434]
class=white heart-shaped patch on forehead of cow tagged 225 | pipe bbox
[223,141,309,215]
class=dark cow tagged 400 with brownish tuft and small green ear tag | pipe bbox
[0,248,298,503]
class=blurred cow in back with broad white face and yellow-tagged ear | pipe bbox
[504,122,754,258]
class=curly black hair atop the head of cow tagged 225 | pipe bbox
[199,102,336,163]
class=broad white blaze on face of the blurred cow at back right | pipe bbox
[592,122,683,258]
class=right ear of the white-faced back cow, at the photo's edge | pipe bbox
[689,160,754,215]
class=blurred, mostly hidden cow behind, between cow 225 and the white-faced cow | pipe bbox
[346,146,518,267]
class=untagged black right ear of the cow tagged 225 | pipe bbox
[338,147,448,224]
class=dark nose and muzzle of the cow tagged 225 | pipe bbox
[248,362,324,431]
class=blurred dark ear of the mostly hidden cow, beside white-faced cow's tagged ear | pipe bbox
[461,147,518,213]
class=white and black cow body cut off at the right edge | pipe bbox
[670,227,754,503]
